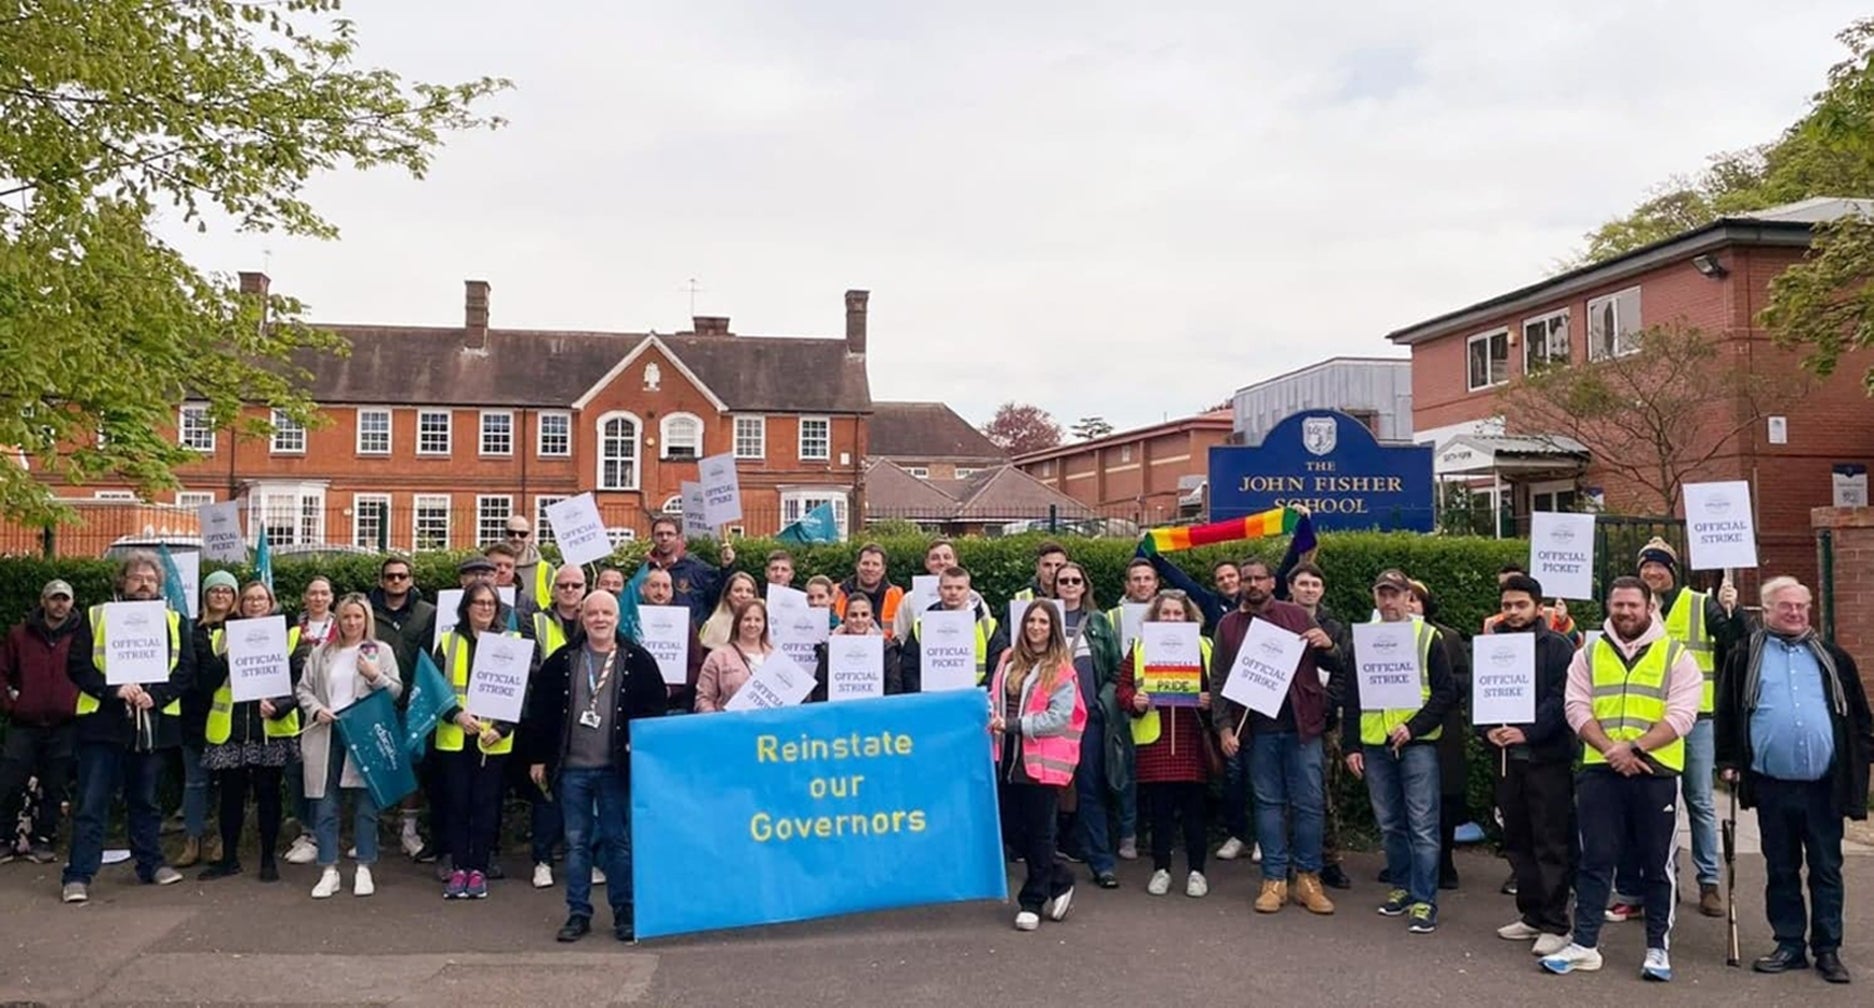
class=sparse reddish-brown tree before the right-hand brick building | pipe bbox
[1497,326,1805,515]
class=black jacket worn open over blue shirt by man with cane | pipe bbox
[1711,630,1874,821]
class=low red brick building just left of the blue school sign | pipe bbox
[1014,408,1231,525]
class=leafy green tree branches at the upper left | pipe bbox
[0,0,508,521]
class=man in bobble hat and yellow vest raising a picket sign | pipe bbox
[1608,536,1750,920]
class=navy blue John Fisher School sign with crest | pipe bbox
[1211,410,1432,532]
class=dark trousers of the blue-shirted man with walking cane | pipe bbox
[1750,772,1846,954]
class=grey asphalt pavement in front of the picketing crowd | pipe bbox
[0,816,1874,1008]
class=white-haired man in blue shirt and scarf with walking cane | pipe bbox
[1715,577,1874,984]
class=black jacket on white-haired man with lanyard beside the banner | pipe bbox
[517,633,665,781]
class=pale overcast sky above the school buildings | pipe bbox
[168,0,1865,427]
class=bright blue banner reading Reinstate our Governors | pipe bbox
[632,689,1008,939]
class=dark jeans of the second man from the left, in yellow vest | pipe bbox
[62,742,163,884]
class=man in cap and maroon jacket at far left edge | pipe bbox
[0,581,79,864]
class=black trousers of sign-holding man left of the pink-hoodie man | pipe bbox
[1497,759,1574,935]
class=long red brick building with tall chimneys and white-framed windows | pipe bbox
[16,274,871,553]
